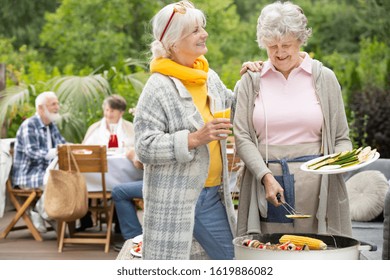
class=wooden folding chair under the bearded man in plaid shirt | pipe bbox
[0,144,43,241]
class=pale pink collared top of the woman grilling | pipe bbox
[253,53,323,145]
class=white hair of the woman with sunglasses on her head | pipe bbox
[150,1,206,59]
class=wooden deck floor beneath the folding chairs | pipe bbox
[0,211,122,260]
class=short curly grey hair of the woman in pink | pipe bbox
[257,1,311,49]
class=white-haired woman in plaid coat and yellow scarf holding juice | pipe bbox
[134,1,235,259]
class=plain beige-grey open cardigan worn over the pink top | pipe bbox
[234,60,352,236]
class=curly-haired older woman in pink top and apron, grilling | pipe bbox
[234,2,352,236]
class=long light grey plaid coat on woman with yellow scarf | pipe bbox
[134,69,236,259]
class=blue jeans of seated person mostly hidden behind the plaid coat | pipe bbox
[112,181,143,240]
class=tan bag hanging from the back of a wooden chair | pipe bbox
[44,146,88,221]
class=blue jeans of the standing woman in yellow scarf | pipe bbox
[194,186,234,260]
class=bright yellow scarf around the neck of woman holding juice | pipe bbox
[150,55,209,85]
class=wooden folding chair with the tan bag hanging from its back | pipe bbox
[58,145,114,253]
